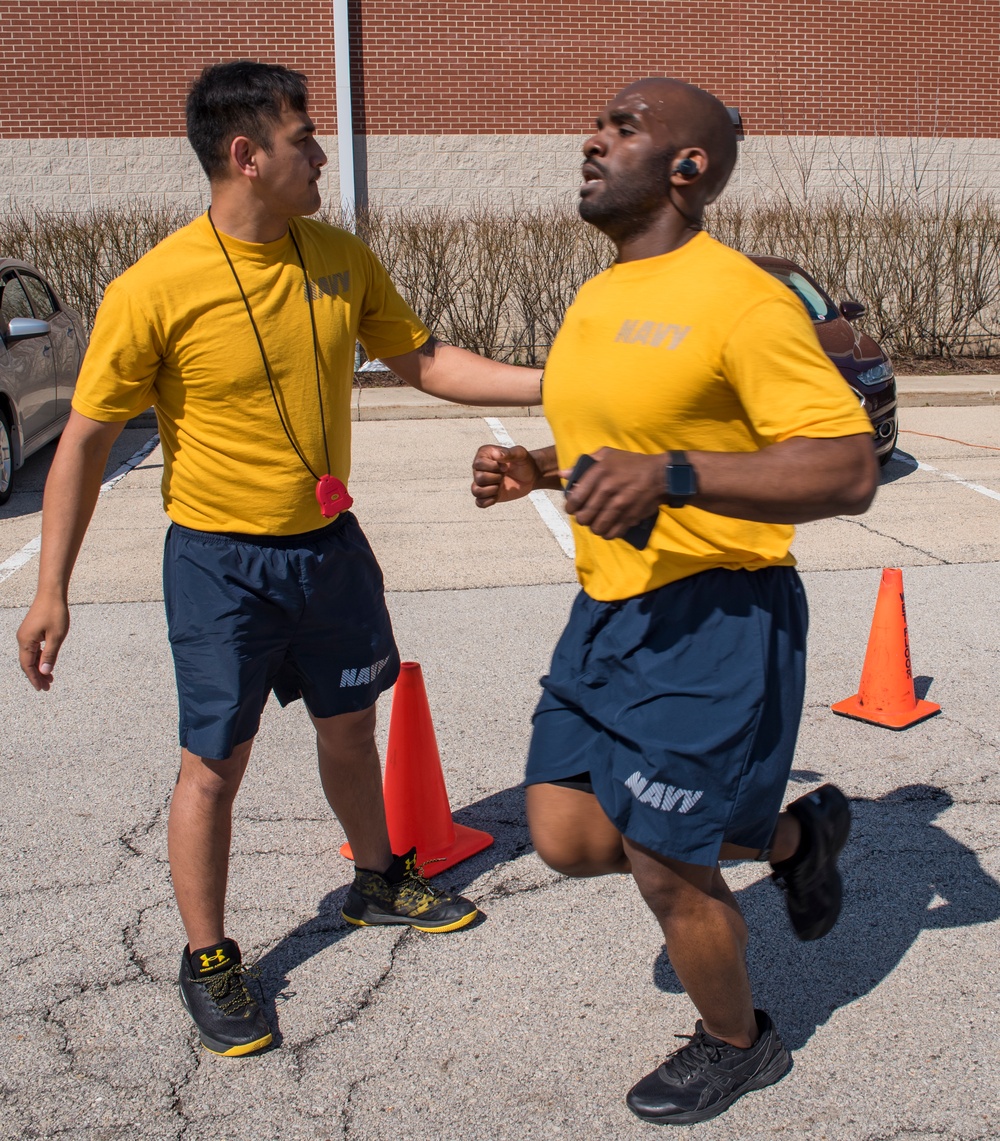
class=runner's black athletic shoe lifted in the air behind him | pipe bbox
[773,785,850,942]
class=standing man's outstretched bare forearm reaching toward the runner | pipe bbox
[384,341,542,407]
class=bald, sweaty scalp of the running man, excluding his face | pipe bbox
[618,76,736,203]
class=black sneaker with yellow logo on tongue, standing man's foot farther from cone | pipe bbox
[179,939,272,1058]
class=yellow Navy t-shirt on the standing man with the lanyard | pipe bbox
[73,216,429,535]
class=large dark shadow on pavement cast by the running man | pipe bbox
[653,785,1000,1050]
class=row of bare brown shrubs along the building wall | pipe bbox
[0,193,1000,364]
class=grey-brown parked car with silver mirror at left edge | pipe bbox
[0,258,87,503]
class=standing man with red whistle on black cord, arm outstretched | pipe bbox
[17,60,540,1054]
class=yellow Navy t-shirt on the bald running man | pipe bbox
[543,234,871,601]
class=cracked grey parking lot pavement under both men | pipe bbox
[0,399,1000,1141]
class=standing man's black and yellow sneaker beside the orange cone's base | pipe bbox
[340,848,479,932]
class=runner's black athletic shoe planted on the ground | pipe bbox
[626,1010,791,1125]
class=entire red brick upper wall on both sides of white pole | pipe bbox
[0,0,1000,138]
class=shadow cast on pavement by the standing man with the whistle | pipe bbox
[256,785,531,1045]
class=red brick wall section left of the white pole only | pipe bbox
[0,0,336,138]
